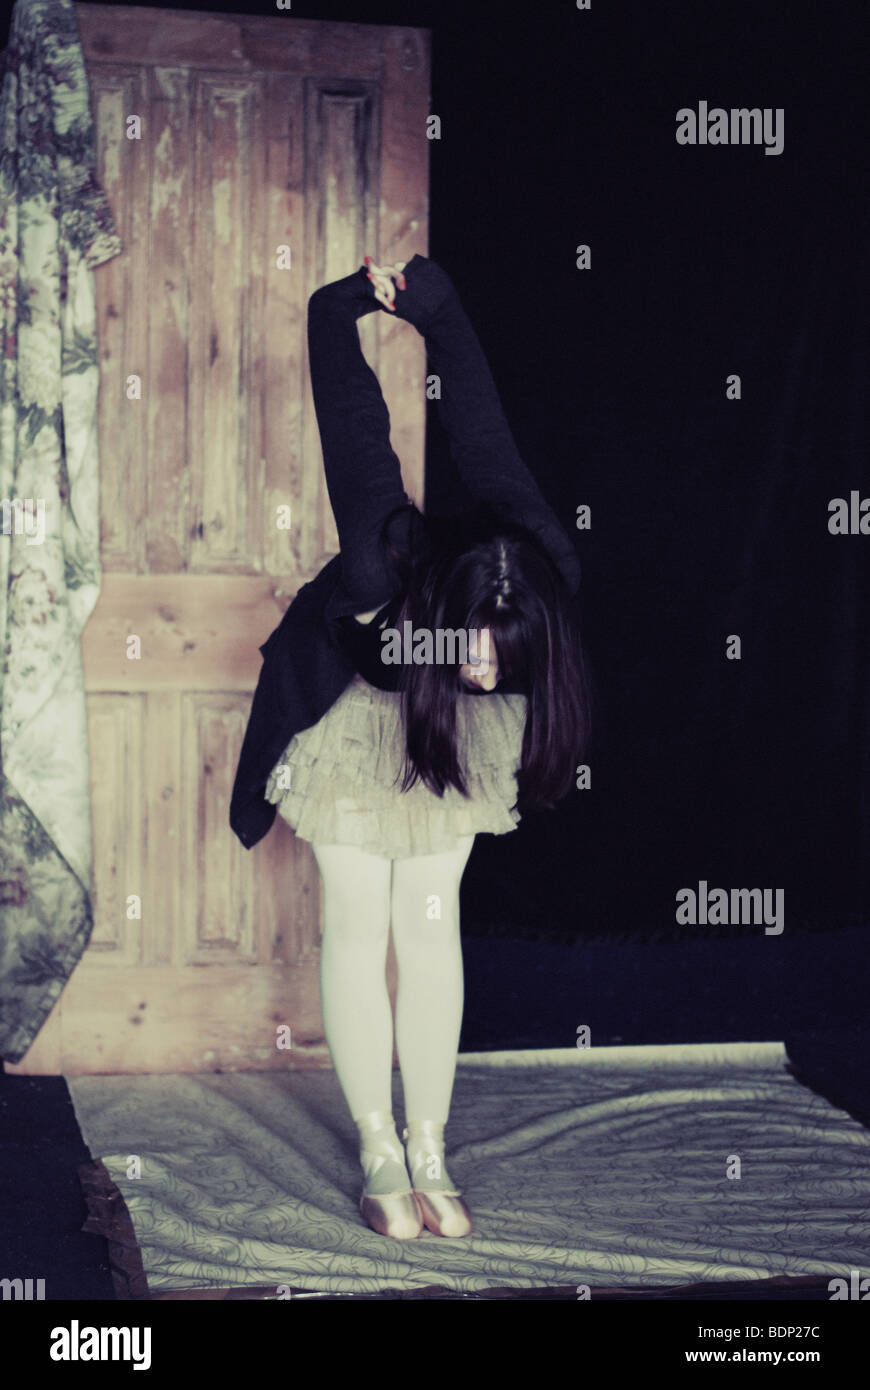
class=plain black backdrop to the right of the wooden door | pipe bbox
[5,0,870,1045]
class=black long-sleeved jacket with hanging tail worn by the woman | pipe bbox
[229,256,580,849]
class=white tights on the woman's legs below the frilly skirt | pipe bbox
[311,835,474,1123]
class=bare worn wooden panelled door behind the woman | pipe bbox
[6,4,429,1073]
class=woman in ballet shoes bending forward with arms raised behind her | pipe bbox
[265,256,588,1238]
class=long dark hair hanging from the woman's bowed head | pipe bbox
[372,503,591,810]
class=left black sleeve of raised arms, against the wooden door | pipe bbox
[309,265,413,617]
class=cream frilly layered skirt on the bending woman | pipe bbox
[265,676,527,859]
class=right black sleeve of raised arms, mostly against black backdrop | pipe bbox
[389,256,581,594]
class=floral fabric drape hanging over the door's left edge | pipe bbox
[0,0,122,1062]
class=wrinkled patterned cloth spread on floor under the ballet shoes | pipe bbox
[67,1043,870,1297]
